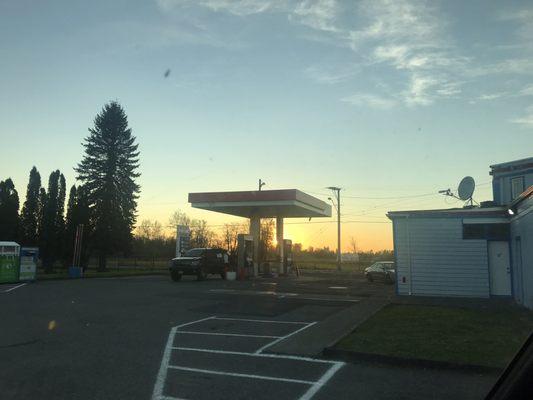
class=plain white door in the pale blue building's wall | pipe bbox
[487,241,511,296]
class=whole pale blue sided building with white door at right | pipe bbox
[388,158,533,308]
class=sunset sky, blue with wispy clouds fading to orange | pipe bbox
[0,0,533,251]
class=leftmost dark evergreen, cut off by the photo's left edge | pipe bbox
[0,178,20,241]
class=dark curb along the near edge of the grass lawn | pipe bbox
[322,347,504,374]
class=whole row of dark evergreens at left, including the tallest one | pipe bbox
[0,101,140,272]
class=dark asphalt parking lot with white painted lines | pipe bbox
[0,275,495,400]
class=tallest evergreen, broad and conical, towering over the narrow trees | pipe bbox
[75,101,140,271]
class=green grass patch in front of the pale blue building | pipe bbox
[336,305,533,367]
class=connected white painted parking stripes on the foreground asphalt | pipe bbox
[152,316,344,400]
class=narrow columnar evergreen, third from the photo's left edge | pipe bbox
[40,170,65,273]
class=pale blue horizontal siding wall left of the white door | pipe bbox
[393,217,490,297]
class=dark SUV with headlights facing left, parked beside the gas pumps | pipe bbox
[170,248,229,281]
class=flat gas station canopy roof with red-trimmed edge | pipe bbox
[189,189,331,218]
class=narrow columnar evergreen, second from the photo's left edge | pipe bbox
[20,167,41,246]
